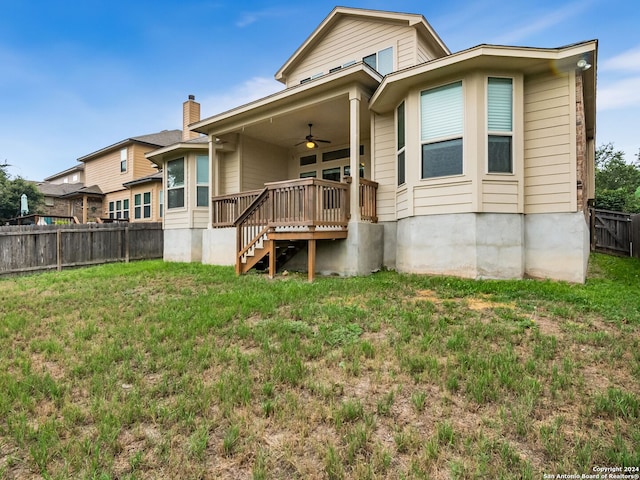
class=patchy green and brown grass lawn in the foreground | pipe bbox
[0,255,640,480]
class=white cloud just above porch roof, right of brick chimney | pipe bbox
[201,77,284,117]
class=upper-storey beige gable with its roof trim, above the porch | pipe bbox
[276,7,449,87]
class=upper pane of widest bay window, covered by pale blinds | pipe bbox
[420,82,464,141]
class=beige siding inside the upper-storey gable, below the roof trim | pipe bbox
[287,18,417,87]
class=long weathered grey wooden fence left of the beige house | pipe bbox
[0,223,163,275]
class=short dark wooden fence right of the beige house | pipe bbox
[589,208,640,258]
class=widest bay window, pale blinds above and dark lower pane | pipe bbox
[420,82,464,178]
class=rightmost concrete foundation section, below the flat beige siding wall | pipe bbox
[525,212,590,283]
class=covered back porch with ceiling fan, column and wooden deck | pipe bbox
[190,64,382,279]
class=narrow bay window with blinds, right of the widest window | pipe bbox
[487,77,513,173]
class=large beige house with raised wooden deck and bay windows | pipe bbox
[148,7,597,282]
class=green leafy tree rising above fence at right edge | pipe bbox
[595,143,640,213]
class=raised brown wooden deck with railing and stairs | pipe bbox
[212,178,378,281]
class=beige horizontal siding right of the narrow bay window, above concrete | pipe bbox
[524,75,576,213]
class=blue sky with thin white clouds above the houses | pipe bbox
[0,0,640,180]
